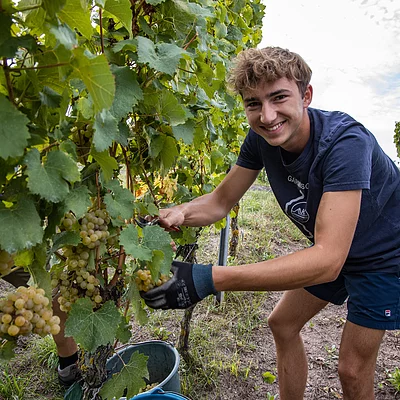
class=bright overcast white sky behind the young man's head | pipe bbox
[259,0,400,161]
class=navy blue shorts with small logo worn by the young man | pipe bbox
[305,271,400,330]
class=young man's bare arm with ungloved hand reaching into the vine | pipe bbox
[160,165,259,230]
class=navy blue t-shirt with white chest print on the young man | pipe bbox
[237,108,400,272]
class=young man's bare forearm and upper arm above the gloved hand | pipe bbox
[213,190,362,290]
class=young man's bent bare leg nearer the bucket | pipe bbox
[268,289,328,400]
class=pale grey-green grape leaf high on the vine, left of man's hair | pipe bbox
[136,36,186,75]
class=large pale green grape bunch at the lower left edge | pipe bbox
[0,286,60,339]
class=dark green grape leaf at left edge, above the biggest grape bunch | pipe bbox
[0,197,43,253]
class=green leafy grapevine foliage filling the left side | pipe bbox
[0,0,264,392]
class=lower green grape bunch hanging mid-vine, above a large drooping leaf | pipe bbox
[51,244,103,313]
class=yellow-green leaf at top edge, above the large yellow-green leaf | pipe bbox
[58,0,93,39]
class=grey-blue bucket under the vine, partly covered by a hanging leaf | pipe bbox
[107,340,181,399]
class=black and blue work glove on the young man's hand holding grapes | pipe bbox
[140,261,217,310]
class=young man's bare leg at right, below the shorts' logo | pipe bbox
[339,321,385,400]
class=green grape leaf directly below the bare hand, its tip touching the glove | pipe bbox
[143,225,174,274]
